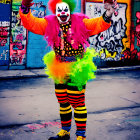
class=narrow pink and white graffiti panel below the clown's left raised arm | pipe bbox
[10,5,27,65]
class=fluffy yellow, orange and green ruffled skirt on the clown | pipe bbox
[43,48,97,90]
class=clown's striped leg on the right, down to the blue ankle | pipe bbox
[67,86,87,139]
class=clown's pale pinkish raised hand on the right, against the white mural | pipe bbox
[104,0,118,17]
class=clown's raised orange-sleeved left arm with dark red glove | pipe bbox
[19,0,48,35]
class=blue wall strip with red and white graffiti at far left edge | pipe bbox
[0,1,11,66]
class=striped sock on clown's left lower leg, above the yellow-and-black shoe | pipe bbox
[60,103,72,131]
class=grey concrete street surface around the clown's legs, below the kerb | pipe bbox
[0,69,140,140]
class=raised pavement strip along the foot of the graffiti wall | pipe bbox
[0,66,140,80]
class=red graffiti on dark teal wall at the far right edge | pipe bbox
[122,1,140,61]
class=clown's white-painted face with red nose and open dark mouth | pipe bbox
[56,2,70,23]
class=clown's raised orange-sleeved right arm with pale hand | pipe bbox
[83,4,115,36]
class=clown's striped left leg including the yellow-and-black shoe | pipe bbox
[49,84,72,140]
